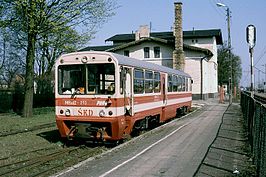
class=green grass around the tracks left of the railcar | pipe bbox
[0,108,110,177]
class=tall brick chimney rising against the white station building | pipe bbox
[173,2,185,71]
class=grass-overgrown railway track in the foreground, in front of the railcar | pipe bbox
[0,145,104,177]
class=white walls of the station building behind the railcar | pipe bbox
[112,37,218,97]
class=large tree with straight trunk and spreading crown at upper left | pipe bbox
[0,0,114,117]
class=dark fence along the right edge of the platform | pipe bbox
[241,92,266,177]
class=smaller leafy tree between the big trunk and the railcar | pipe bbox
[35,28,91,94]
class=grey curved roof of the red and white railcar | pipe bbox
[61,51,191,77]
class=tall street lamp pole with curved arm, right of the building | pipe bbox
[216,3,233,104]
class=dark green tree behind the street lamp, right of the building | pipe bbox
[218,45,242,86]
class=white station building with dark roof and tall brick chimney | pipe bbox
[81,3,222,99]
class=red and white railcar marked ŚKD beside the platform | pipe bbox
[55,51,192,141]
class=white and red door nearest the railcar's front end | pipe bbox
[122,67,134,116]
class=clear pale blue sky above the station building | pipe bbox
[89,0,266,86]
